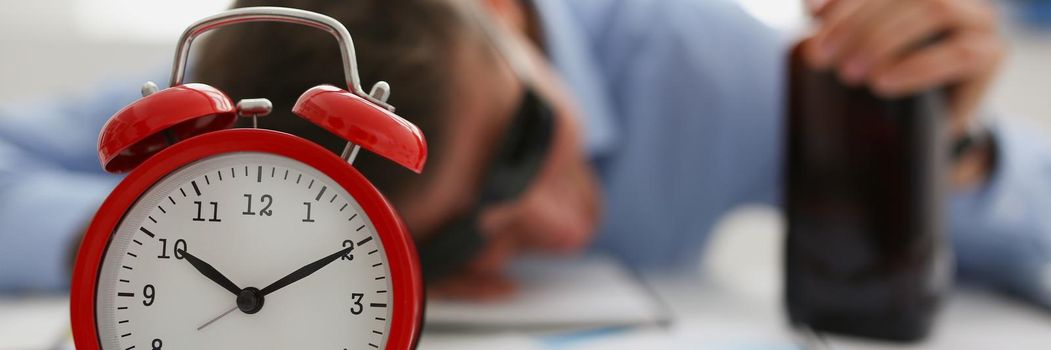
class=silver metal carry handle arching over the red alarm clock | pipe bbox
[169,6,392,109]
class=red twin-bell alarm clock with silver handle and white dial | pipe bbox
[70,7,427,350]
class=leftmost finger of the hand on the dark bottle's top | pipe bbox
[808,0,899,69]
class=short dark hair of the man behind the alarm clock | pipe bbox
[190,0,466,204]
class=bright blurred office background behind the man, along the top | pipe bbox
[0,0,1051,132]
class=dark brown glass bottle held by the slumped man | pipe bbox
[784,41,951,342]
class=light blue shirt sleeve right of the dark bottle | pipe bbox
[949,124,1051,307]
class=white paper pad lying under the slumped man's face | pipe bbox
[427,255,666,331]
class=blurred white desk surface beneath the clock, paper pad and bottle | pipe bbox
[0,277,1051,350]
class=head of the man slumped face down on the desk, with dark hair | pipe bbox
[193,0,599,281]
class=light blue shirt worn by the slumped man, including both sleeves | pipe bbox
[6,0,1051,306]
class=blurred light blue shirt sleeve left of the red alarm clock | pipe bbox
[0,82,138,292]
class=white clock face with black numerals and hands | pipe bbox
[96,152,393,350]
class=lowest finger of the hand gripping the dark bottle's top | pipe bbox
[873,33,1001,97]
